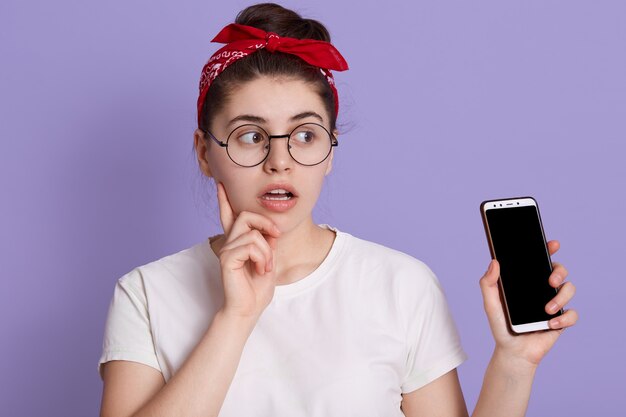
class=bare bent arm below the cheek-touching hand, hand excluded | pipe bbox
[100,312,256,417]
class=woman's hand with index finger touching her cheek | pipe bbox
[217,183,280,319]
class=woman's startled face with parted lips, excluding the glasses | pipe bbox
[196,76,332,233]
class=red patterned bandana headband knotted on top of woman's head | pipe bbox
[198,23,348,125]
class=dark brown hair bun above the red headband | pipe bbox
[235,3,330,42]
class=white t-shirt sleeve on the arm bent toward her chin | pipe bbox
[98,269,161,377]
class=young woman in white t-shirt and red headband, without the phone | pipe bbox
[100,4,577,417]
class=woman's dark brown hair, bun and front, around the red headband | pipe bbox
[199,3,337,131]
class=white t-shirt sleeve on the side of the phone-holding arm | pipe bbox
[402,264,467,394]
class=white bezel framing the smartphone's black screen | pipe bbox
[480,196,563,334]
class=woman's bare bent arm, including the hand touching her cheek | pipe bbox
[101,184,280,417]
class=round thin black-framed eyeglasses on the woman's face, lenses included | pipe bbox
[203,123,339,167]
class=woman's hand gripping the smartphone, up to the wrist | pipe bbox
[480,240,578,366]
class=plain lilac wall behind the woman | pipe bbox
[0,0,626,416]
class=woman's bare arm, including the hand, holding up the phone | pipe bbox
[402,241,578,417]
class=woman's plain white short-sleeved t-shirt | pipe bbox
[100,229,466,417]
